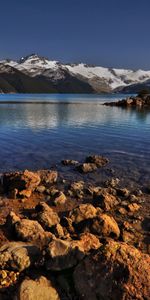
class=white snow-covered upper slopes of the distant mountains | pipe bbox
[0,54,150,92]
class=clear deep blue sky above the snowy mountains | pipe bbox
[0,0,150,69]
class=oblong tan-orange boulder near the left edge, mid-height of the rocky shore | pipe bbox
[15,219,52,245]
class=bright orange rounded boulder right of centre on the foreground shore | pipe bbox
[91,214,120,238]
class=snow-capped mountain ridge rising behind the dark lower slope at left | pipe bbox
[0,54,150,93]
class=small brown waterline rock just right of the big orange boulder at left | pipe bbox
[38,170,58,185]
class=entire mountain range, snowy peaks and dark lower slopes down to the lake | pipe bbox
[0,54,150,93]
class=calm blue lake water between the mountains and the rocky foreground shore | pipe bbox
[0,94,150,188]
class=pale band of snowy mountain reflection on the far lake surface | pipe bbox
[0,103,150,129]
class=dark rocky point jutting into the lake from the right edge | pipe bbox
[104,94,150,107]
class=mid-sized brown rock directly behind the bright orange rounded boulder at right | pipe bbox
[93,190,119,211]
